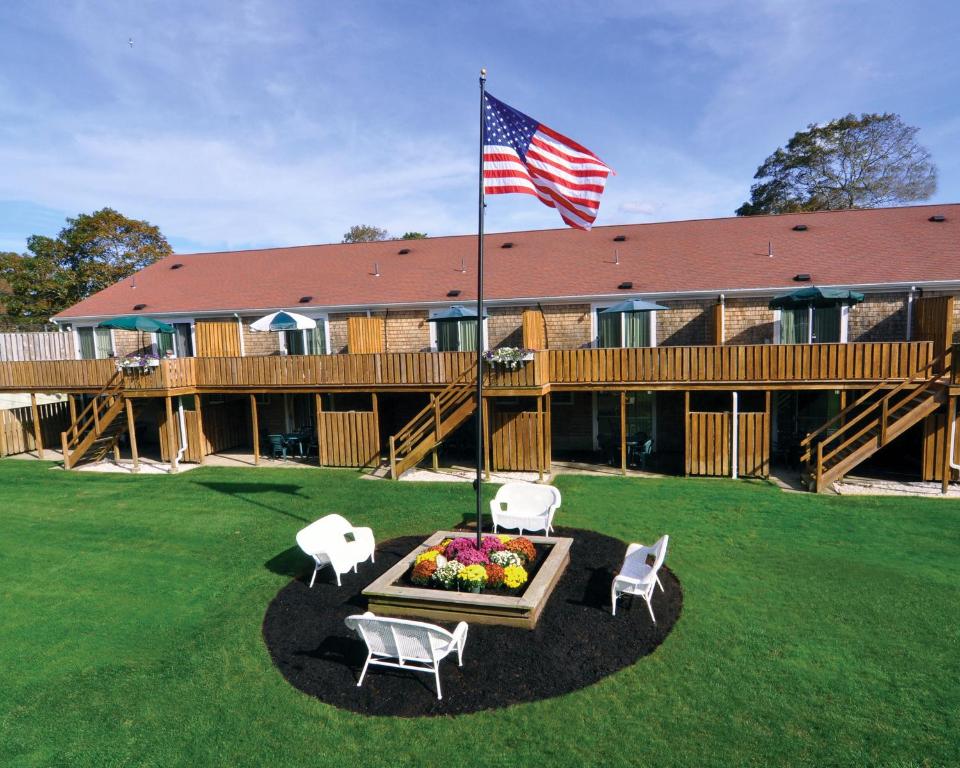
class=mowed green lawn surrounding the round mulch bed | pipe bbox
[0,460,960,767]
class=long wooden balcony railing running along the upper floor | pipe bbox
[0,341,940,397]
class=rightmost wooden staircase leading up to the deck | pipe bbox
[800,351,949,493]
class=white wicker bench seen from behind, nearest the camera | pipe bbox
[345,611,467,699]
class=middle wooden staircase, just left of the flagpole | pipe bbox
[390,365,477,480]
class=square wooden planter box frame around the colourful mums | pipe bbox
[363,531,573,629]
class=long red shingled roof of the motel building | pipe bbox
[58,204,960,318]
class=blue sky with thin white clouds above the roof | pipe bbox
[0,0,960,251]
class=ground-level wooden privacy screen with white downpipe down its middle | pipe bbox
[685,411,770,477]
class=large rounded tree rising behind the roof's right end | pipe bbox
[736,113,937,216]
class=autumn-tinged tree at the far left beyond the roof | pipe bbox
[0,208,173,324]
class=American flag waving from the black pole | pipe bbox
[483,93,611,229]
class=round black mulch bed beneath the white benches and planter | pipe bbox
[263,529,683,717]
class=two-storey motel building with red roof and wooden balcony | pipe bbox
[0,205,960,490]
